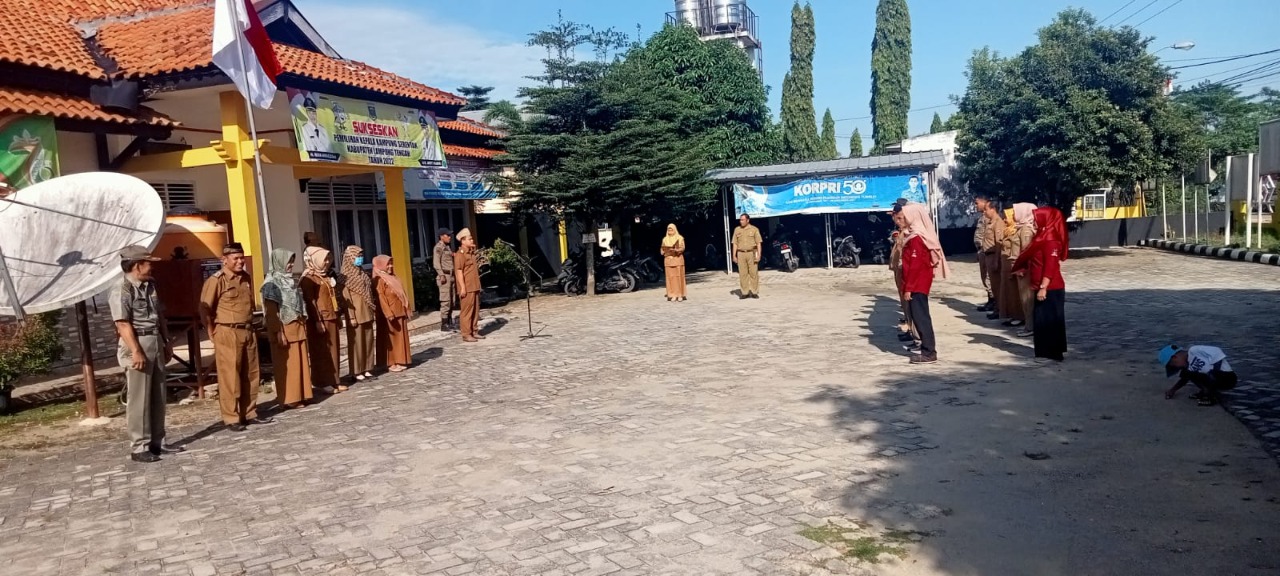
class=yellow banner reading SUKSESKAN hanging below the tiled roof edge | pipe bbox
[285,88,445,168]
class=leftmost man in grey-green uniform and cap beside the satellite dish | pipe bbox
[109,246,183,462]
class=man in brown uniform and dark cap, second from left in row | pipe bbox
[200,242,274,431]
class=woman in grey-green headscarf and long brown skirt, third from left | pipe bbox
[262,248,311,408]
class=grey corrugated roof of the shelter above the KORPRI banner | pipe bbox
[707,150,945,184]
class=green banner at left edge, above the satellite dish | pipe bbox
[0,116,59,189]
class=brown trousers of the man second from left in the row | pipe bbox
[212,326,261,424]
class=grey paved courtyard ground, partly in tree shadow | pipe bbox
[0,250,1280,576]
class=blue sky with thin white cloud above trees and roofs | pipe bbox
[296,0,1280,151]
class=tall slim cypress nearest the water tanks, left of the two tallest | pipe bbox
[782,3,822,161]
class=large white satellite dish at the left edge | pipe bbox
[0,172,165,315]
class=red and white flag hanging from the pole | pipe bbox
[214,0,280,109]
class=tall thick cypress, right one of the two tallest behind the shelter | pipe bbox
[872,0,911,154]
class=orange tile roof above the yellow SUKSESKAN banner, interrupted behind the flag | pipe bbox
[97,8,466,105]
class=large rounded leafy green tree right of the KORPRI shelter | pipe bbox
[957,10,1204,209]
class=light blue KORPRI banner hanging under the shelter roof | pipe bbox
[733,170,928,218]
